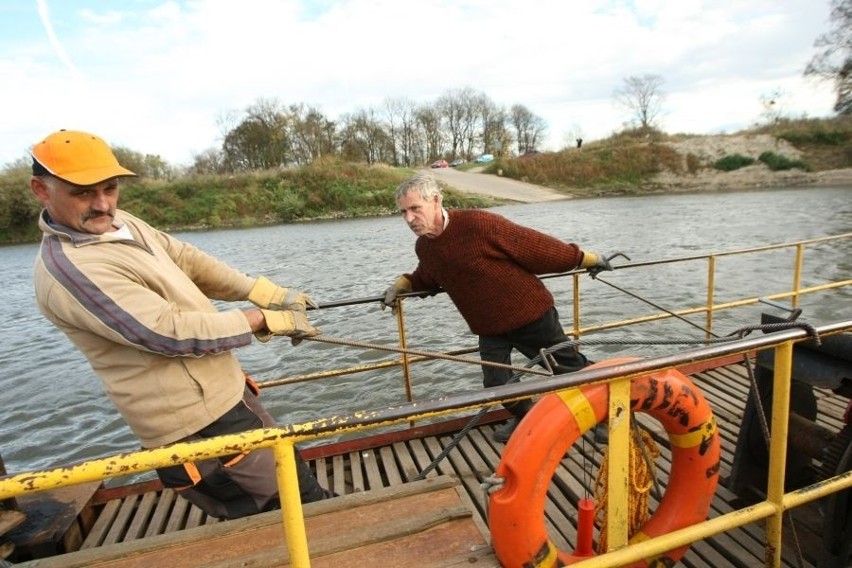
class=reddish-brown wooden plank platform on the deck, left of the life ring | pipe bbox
[31,477,498,568]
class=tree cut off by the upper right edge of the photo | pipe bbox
[805,0,852,115]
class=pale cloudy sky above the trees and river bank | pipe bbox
[0,0,835,166]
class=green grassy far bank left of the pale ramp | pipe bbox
[0,160,495,244]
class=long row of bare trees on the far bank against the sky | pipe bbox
[190,88,547,174]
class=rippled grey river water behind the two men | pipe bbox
[0,187,852,480]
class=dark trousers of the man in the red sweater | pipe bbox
[479,308,591,419]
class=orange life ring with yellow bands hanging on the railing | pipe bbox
[488,358,721,568]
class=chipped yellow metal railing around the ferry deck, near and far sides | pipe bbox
[0,233,852,566]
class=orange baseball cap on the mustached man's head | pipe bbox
[32,130,136,185]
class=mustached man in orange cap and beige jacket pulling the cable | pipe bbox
[30,130,331,518]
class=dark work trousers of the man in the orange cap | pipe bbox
[157,387,331,519]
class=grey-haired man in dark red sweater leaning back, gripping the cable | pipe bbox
[383,173,612,442]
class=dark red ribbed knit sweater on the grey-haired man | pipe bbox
[406,209,583,335]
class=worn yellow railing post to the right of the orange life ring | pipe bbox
[764,341,793,566]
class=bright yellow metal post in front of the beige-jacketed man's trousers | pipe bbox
[273,439,311,568]
